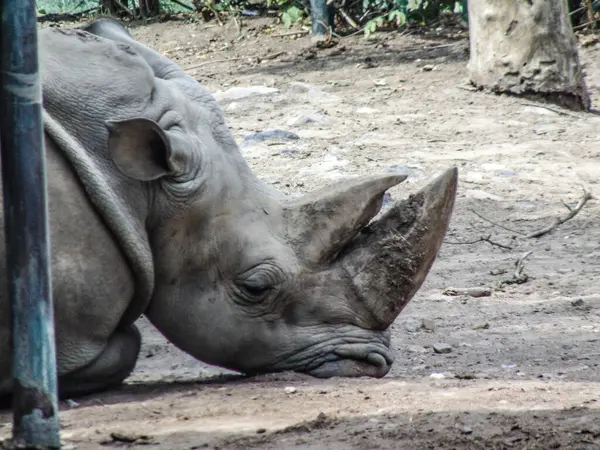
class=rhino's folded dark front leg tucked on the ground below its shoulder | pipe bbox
[58,325,142,399]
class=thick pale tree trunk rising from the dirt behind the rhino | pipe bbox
[468,0,591,111]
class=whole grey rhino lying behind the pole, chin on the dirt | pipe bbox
[0,19,457,398]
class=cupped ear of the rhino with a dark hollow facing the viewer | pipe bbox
[105,117,177,181]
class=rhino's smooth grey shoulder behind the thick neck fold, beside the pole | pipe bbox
[0,137,134,394]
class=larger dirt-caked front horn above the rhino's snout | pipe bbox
[339,168,458,329]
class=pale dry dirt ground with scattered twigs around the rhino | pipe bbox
[0,15,600,450]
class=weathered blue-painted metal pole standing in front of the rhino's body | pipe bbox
[0,0,60,449]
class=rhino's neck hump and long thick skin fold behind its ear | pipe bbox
[38,28,158,320]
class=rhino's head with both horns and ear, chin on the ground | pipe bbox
[81,21,457,377]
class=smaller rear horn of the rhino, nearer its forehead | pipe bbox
[284,175,406,263]
